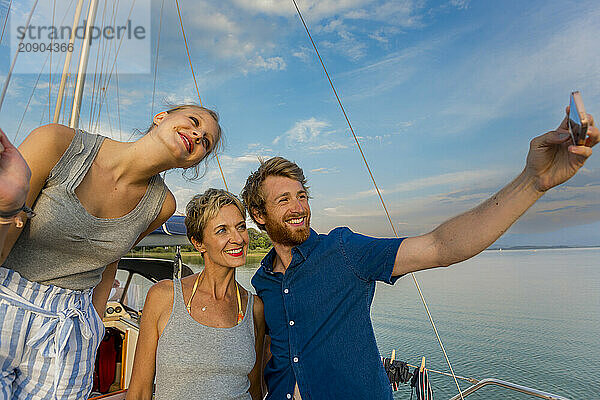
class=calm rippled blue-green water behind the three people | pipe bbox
[189,248,600,400]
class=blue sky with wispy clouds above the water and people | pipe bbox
[0,0,600,246]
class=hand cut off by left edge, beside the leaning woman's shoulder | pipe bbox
[0,129,31,213]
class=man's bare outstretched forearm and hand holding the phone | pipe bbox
[392,111,600,276]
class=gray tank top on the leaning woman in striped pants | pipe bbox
[3,130,167,290]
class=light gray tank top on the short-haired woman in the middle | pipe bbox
[155,279,256,400]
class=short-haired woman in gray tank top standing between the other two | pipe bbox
[127,189,265,400]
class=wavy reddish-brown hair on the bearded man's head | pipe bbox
[241,157,308,231]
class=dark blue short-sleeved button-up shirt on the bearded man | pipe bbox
[252,228,402,400]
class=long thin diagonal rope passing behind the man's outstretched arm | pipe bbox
[292,0,463,399]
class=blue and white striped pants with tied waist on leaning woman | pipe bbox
[0,267,104,400]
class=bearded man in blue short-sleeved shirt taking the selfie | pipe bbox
[242,116,600,400]
